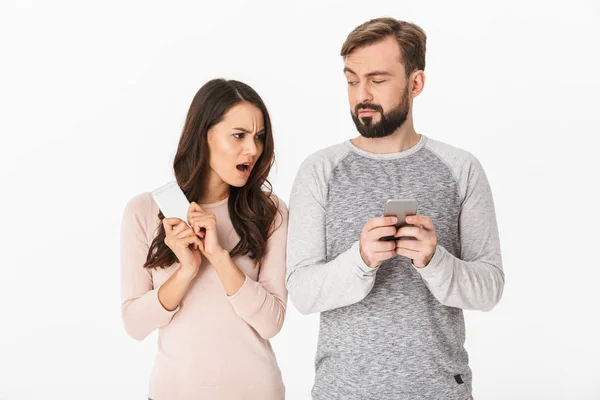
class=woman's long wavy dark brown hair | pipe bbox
[144,79,278,268]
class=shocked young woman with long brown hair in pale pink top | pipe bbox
[121,79,287,400]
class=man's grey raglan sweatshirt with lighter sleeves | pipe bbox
[287,135,504,400]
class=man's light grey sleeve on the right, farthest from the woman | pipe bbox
[417,155,504,311]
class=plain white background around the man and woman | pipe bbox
[0,0,600,400]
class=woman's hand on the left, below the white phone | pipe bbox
[163,218,202,278]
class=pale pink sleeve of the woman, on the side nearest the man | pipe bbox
[228,199,288,339]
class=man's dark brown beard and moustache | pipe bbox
[350,88,409,138]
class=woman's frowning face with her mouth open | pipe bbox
[208,101,265,187]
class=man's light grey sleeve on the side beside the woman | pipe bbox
[287,153,377,314]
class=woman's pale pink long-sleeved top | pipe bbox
[121,193,288,400]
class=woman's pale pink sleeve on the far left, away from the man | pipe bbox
[121,193,179,340]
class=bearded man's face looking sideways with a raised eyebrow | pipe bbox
[344,37,410,138]
